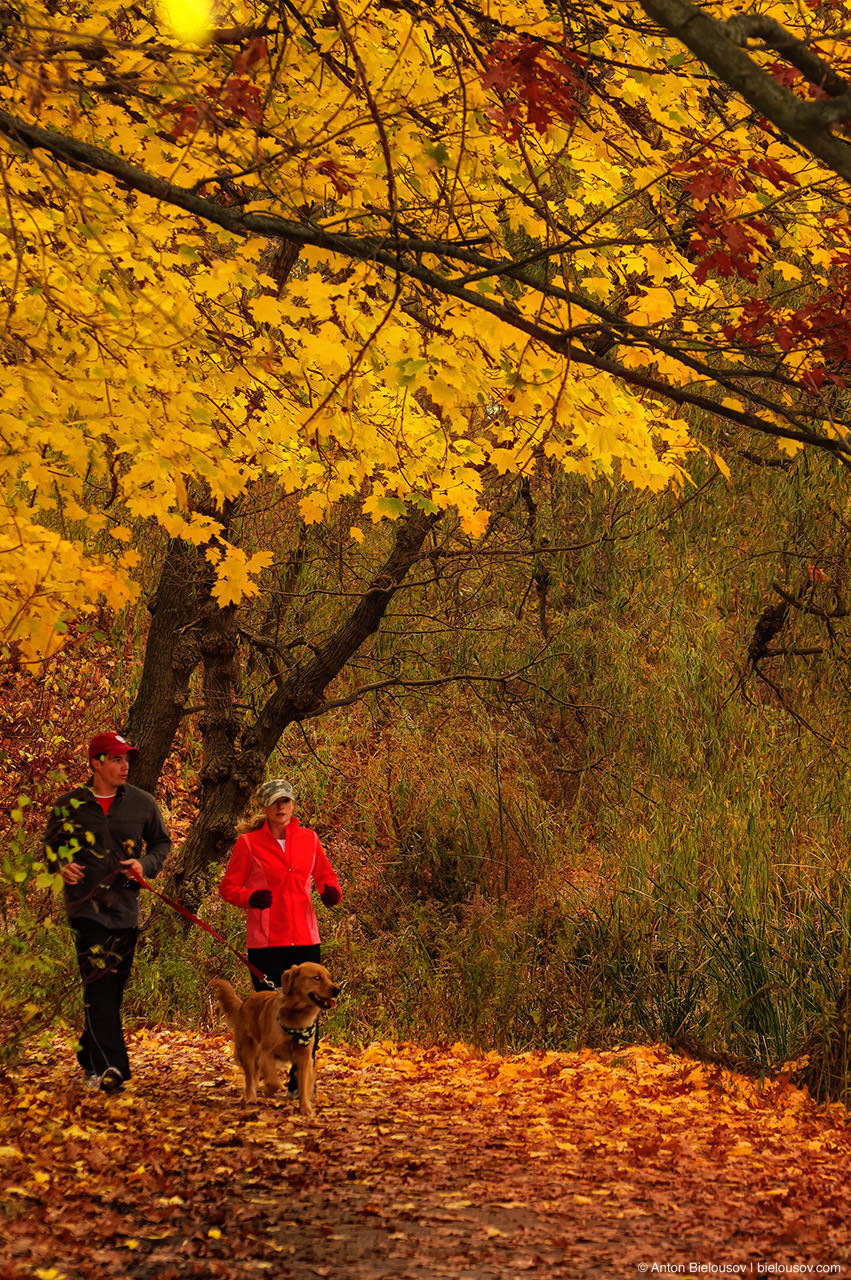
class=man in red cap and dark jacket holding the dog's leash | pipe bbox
[45,732,171,1093]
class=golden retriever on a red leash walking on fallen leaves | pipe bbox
[210,961,340,1116]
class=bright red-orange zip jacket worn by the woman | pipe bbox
[219,818,340,947]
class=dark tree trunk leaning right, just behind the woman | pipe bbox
[174,511,436,896]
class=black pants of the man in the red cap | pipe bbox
[70,919,139,1080]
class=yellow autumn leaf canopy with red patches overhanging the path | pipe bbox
[0,0,851,658]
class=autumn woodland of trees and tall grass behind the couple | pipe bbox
[0,0,851,1093]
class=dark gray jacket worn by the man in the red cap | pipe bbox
[45,783,171,929]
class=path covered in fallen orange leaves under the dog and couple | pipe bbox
[0,1028,851,1280]
